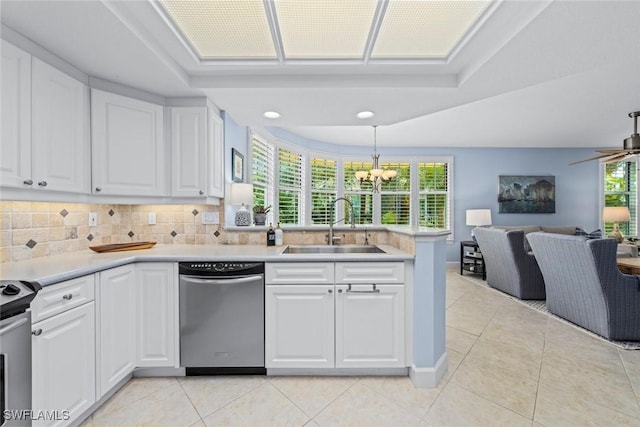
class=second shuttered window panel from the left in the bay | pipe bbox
[278,148,304,225]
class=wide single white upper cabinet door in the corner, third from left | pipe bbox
[91,89,167,196]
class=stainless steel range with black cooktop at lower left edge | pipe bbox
[0,280,41,427]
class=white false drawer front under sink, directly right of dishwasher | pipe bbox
[265,262,334,285]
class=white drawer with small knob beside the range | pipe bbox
[31,274,95,323]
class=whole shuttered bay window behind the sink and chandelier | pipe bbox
[251,136,453,236]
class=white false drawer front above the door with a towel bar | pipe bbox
[336,262,404,284]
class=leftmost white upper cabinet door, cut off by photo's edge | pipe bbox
[0,40,33,188]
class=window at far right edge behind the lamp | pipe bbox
[603,159,638,236]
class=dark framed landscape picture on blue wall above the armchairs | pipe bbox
[498,175,556,213]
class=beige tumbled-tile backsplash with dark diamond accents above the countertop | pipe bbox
[0,201,404,262]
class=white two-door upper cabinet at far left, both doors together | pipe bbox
[0,41,90,193]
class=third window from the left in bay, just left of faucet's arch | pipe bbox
[310,157,338,224]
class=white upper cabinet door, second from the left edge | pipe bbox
[32,58,91,193]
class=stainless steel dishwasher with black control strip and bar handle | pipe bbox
[179,262,266,375]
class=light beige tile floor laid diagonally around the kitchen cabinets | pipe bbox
[83,270,640,427]
